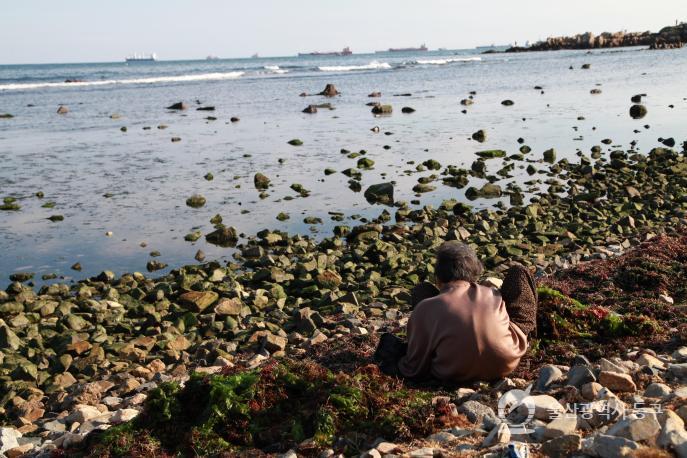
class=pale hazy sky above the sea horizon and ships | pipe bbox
[0,0,687,64]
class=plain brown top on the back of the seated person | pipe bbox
[398,282,527,382]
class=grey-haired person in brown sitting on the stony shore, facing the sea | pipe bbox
[376,242,537,383]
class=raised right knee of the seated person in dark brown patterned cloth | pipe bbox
[501,264,537,336]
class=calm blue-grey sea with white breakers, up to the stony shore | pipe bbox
[0,48,687,285]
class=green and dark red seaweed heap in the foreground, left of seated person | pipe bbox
[90,360,446,456]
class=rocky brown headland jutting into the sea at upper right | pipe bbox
[506,23,687,52]
